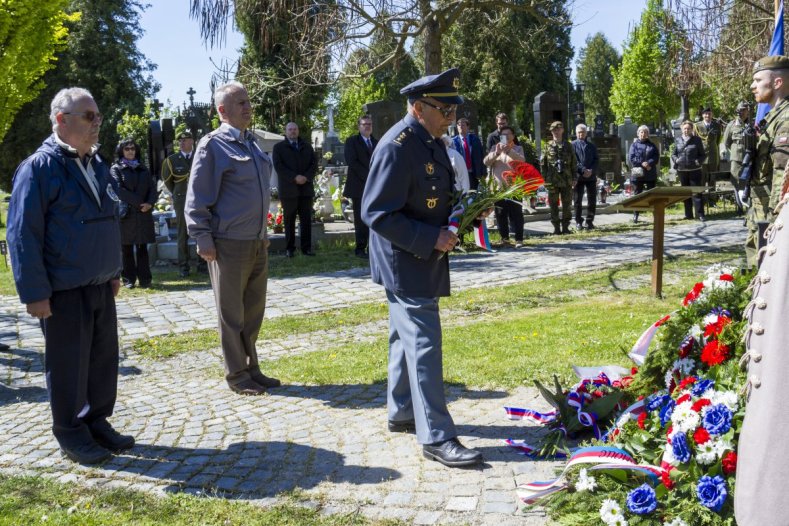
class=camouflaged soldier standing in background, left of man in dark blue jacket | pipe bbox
[540,121,576,235]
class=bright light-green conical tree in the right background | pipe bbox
[611,0,675,123]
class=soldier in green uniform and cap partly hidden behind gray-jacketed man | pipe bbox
[162,131,194,277]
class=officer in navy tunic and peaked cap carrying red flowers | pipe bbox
[362,69,482,466]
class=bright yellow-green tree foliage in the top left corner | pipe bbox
[0,0,79,140]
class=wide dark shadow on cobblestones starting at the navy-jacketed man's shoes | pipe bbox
[112,441,401,500]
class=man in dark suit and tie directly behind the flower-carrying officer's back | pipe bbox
[342,115,378,259]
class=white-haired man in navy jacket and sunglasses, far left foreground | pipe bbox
[8,88,134,464]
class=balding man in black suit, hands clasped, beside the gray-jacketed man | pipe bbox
[273,122,318,258]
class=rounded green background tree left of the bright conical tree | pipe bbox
[576,33,622,127]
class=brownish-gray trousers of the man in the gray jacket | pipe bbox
[208,239,268,385]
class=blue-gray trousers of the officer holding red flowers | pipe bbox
[386,290,457,444]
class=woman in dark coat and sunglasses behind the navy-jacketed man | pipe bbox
[110,139,157,289]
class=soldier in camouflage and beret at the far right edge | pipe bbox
[745,55,789,268]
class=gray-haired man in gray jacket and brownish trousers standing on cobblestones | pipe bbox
[184,82,280,395]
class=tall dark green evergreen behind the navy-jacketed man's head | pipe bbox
[0,0,158,193]
